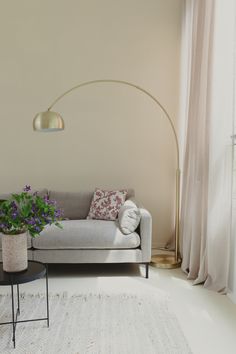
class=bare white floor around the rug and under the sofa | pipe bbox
[0,265,236,354]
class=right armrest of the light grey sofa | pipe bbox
[139,207,152,262]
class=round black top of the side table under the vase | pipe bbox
[0,261,46,285]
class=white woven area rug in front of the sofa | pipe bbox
[0,292,191,354]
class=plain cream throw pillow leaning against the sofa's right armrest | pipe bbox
[118,198,141,235]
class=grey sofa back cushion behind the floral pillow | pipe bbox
[49,189,134,220]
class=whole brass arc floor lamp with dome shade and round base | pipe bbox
[33,79,181,268]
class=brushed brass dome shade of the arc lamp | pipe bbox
[33,111,65,132]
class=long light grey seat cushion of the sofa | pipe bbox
[33,220,140,249]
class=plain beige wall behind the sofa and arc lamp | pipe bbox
[0,0,182,246]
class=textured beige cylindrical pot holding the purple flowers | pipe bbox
[2,233,28,272]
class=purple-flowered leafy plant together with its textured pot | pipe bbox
[0,186,62,272]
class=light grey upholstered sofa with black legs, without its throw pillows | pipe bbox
[0,190,152,277]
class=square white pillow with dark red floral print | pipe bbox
[87,189,128,220]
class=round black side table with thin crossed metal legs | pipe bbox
[0,261,49,348]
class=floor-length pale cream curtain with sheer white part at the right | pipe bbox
[180,0,235,293]
